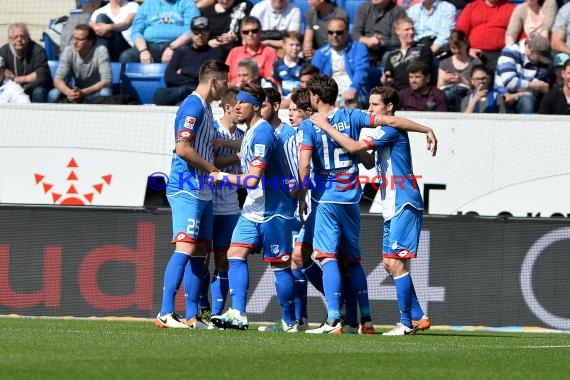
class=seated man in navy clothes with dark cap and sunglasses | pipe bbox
[153,16,224,106]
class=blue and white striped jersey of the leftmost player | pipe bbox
[166,92,215,200]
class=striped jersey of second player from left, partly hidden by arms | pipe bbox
[214,121,244,215]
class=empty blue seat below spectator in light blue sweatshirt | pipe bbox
[122,62,166,104]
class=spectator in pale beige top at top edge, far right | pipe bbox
[505,0,558,46]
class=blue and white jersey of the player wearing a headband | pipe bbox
[240,120,293,223]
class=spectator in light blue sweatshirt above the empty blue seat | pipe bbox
[119,0,200,63]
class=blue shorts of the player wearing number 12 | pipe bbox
[312,203,360,263]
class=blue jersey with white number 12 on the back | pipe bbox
[298,108,374,204]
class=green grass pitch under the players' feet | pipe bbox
[0,318,570,380]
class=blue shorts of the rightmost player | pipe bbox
[382,206,424,259]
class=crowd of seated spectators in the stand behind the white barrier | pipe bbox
[0,0,570,114]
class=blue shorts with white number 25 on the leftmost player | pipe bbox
[167,195,214,244]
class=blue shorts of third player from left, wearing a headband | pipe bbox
[231,216,293,262]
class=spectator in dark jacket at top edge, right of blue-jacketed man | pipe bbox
[352,0,406,66]
